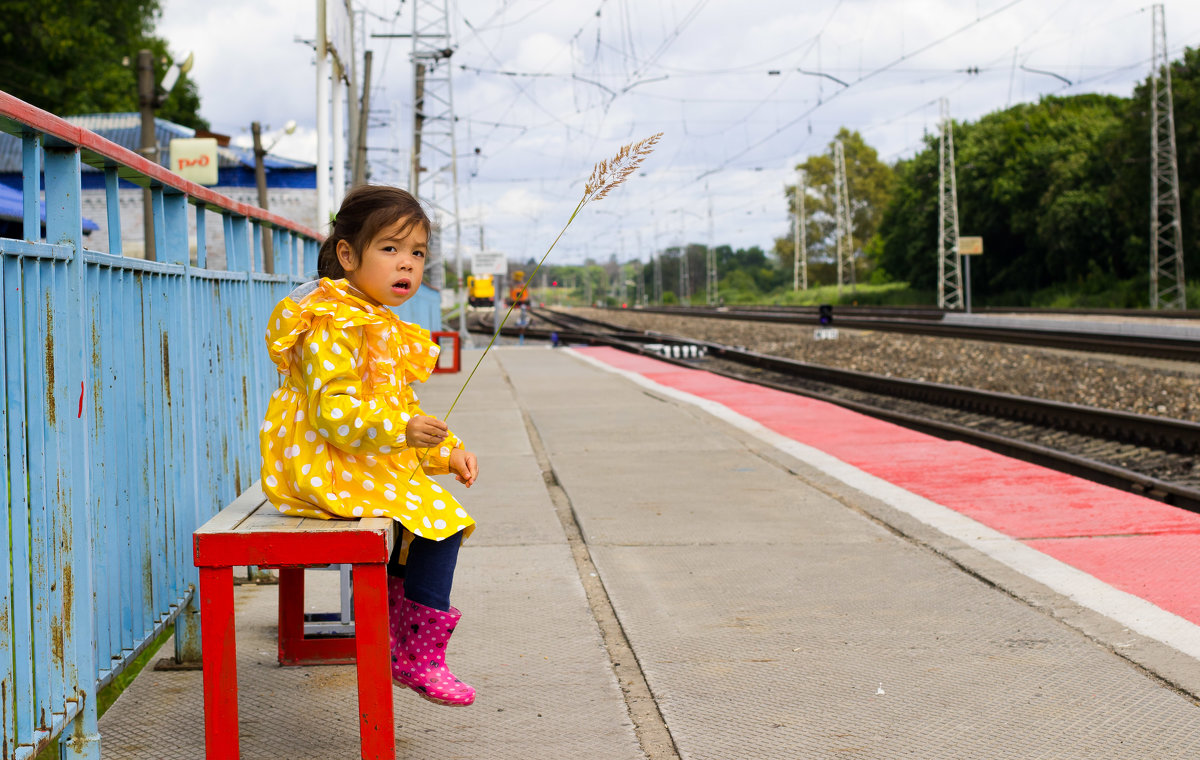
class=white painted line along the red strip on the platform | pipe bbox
[565,349,1200,659]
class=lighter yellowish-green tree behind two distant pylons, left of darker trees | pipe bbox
[774,127,895,283]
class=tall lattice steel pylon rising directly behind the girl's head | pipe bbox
[408,0,466,292]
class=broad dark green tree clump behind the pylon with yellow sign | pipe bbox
[880,95,1128,299]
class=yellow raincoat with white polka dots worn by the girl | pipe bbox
[258,279,475,540]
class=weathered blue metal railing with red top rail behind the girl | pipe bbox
[0,92,440,760]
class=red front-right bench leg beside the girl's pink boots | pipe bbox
[354,563,396,760]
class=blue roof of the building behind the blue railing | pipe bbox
[0,113,317,174]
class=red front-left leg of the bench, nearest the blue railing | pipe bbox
[200,568,239,760]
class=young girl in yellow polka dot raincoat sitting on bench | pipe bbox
[259,186,478,705]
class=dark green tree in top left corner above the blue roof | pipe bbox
[0,0,208,128]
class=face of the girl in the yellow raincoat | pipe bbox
[337,219,430,306]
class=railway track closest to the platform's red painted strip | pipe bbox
[482,309,1200,511]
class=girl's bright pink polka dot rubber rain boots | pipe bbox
[391,599,475,707]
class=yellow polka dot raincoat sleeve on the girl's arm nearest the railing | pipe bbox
[300,321,420,454]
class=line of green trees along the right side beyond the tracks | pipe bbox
[775,48,1200,307]
